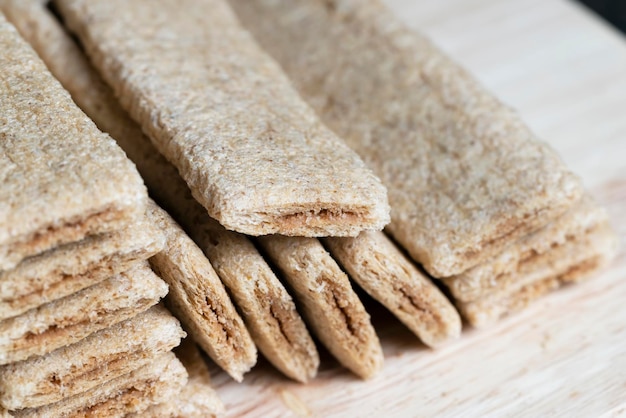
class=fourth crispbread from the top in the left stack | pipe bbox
[0,306,185,410]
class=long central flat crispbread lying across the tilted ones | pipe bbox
[56,0,389,236]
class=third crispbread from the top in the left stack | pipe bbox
[0,262,167,364]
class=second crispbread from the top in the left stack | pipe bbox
[0,219,164,320]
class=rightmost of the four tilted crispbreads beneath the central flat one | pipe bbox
[322,232,461,347]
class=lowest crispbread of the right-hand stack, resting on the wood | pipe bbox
[457,222,617,327]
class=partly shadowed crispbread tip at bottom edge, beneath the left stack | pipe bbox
[137,338,224,418]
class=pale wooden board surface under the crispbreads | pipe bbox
[212,0,626,417]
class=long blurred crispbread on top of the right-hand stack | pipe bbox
[230,0,582,277]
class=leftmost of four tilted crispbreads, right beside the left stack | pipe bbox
[149,203,257,381]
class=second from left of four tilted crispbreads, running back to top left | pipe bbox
[14,4,319,382]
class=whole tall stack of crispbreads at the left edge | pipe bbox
[0,11,206,417]
